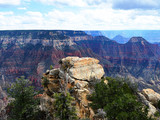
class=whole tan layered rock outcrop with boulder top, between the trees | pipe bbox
[41,57,105,119]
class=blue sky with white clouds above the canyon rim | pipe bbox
[0,0,160,30]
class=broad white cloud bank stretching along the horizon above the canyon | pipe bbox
[0,8,160,30]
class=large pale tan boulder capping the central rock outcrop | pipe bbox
[61,57,104,81]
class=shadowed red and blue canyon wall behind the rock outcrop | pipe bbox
[0,30,160,91]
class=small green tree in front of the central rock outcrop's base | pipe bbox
[53,93,77,120]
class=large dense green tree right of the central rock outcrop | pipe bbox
[90,77,151,120]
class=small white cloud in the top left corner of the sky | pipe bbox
[0,0,21,5]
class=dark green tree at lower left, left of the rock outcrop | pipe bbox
[8,77,44,120]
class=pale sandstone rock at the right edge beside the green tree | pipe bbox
[142,89,160,105]
